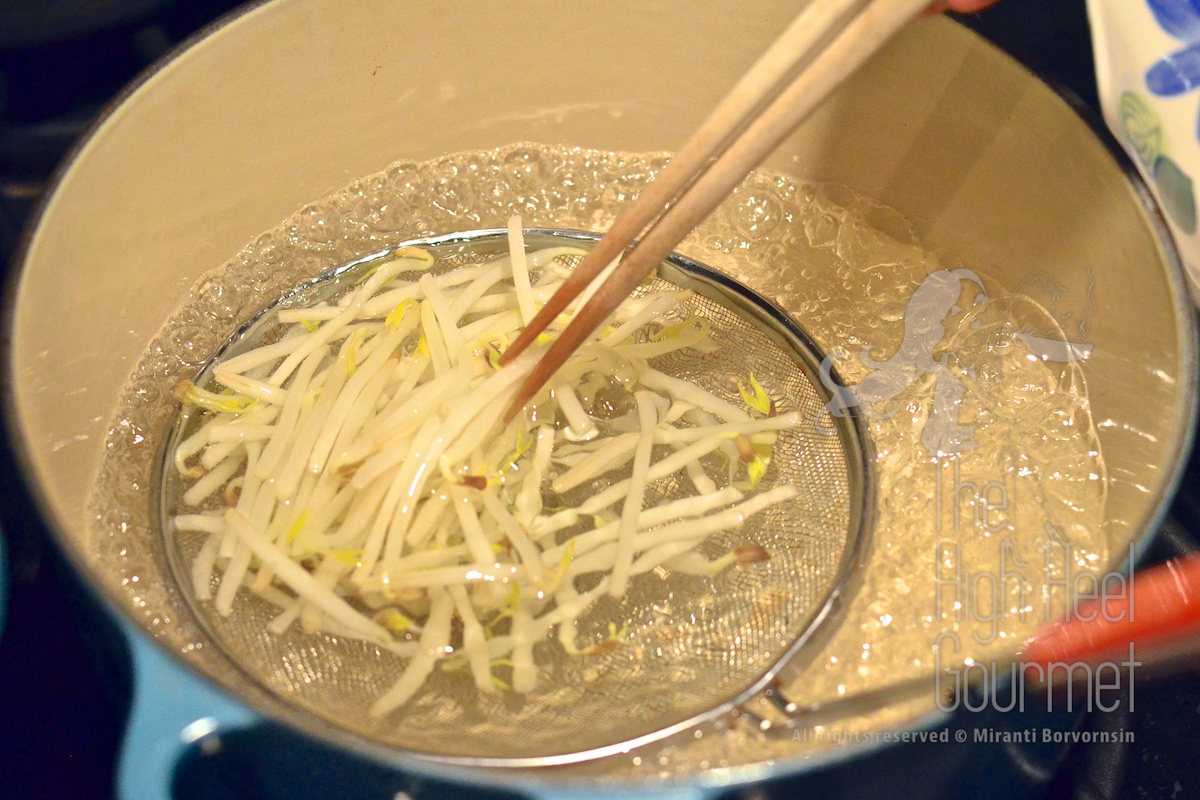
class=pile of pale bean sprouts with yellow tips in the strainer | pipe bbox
[173,218,799,716]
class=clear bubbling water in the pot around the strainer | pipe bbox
[91,144,1110,775]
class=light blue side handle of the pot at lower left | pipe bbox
[116,625,258,800]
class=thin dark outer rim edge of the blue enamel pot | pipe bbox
[0,6,1200,794]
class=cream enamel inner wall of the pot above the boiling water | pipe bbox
[6,0,1195,793]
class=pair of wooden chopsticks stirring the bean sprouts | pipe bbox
[500,0,929,421]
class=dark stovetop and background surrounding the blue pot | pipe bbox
[0,0,1200,800]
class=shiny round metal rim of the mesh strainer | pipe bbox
[150,228,875,769]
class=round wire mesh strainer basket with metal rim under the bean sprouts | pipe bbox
[155,230,870,766]
